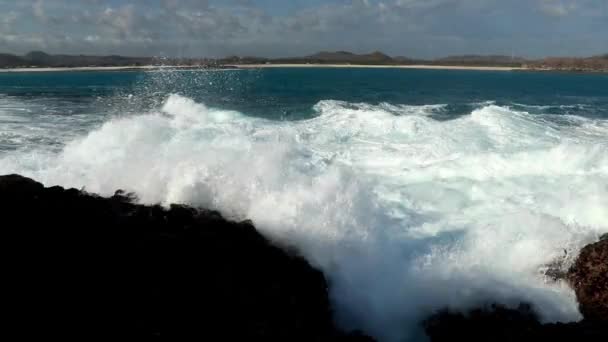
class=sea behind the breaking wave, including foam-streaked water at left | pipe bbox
[0,68,608,151]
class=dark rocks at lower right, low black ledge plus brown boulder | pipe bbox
[423,240,608,341]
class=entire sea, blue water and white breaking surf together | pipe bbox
[0,69,608,341]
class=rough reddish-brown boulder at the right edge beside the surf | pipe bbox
[568,239,608,325]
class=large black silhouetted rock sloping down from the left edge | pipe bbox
[0,175,366,341]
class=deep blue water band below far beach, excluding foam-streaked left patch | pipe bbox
[0,68,608,119]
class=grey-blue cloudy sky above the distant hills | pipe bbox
[0,0,608,58]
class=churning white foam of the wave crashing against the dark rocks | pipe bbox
[0,95,608,341]
